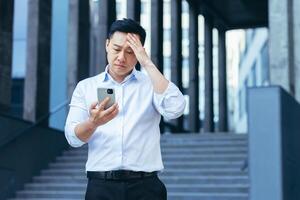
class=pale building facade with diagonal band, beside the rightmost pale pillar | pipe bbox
[234,28,270,133]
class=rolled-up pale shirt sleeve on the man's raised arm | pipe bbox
[153,81,186,119]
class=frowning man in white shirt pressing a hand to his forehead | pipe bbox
[65,19,185,200]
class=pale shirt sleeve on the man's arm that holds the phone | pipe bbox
[65,83,88,147]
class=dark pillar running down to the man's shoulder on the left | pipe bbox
[68,0,90,98]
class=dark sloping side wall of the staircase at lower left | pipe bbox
[0,115,68,200]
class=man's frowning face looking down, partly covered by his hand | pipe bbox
[106,32,137,80]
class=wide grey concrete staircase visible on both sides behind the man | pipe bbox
[8,133,249,200]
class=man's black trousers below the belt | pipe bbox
[85,176,167,200]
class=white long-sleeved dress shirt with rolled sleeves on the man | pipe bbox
[65,67,186,172]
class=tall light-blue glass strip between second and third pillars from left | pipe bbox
[49,0,69,130]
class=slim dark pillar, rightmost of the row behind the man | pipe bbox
[218,29,228,132]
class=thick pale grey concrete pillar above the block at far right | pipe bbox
[268,0,298,95]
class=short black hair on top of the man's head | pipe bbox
[107,18,146,45]
